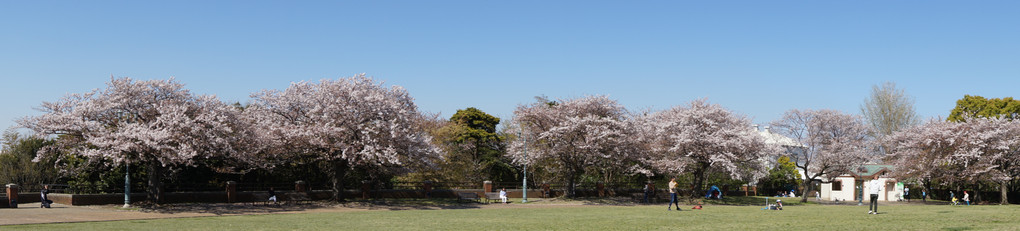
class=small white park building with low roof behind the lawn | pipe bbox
[820,165,903,201]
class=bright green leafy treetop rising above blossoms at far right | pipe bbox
[948,95,1020,122]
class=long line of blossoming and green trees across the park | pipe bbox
[4,75,1020,202]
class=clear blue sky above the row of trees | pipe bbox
[0,0,1020,129]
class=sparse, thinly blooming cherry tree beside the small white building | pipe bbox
[772,109,870,201]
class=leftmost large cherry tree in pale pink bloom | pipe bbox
[18,78,257,202]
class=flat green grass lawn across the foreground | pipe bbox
[2,201,1020,230]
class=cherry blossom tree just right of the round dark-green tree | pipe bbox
[507,96,641,196]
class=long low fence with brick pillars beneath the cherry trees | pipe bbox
[0,181,767,206]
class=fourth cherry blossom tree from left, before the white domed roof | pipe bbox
[642,99,779,195]
